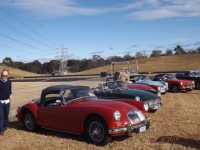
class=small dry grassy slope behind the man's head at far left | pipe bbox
[0,65,39,78]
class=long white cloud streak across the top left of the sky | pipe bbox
[0,0,108,18]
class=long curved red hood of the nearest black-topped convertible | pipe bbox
[71,98,137,112]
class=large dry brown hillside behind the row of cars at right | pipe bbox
[72,54,200,75]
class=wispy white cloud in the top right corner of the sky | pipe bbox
[129,0,200,20]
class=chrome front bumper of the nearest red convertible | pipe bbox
[108,118,150,136]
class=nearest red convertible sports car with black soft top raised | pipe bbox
[16,85,150,145]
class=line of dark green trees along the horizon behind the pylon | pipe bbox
[2,45,200,74]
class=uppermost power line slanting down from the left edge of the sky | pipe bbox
[0,8,56,44]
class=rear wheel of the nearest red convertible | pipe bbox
[23,111,37,131]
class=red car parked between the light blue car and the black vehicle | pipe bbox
[154,74,195,93]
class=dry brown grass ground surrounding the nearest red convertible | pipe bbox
[0,81,200,150]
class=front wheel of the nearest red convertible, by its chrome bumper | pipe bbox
[85,117,112,145]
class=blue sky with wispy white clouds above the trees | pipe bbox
[0,0,200,61]
